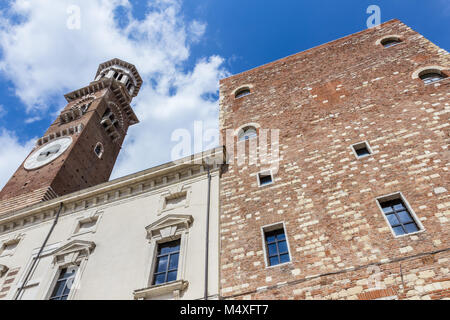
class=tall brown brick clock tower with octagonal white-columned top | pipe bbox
[0,59,142,215]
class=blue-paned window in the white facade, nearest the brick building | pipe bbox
[153,240,180,285]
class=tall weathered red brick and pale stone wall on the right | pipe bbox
[220,20,450,299]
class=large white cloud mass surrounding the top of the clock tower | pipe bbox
[0,0,227,184]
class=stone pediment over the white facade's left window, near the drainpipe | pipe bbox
[53,240,95,266]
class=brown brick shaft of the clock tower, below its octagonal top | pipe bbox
[0,76,135,215]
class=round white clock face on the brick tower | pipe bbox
[24,137,72,170]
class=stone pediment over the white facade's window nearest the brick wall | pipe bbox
[145,214,194,240]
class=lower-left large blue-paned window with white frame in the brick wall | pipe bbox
[264,228,291,266]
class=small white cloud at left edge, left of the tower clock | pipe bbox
[0,129,36,188]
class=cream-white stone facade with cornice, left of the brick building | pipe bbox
[0,148,223,300]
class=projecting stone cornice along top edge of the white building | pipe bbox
[0,147,224,236]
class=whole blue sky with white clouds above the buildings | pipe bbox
[0,0,450,186]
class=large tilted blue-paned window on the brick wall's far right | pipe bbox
[379,197,421,236]
